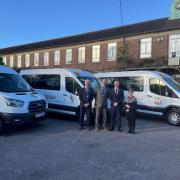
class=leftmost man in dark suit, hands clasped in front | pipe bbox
[79,80,93,130]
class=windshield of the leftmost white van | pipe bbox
[0,73,31,93]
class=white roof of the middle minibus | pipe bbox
[20,68,93,76]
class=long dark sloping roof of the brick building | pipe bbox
[0,18,180,54]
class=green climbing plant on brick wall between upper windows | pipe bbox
[117,37,128,71]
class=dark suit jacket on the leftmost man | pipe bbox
[79,87,93,105]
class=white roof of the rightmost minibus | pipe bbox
[94,71,170,78]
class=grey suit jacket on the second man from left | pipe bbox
[95,86,109,108]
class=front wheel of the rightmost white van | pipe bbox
[166,109,180,126]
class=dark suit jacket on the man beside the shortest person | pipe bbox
[110,88,124,108]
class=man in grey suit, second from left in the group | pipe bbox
[95,79,109,130]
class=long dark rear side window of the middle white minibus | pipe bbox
[23,74,61,90]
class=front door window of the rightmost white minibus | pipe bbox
[149,78,177,98]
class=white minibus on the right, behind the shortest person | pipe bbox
[95,71,180,125]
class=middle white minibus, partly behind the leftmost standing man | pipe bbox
[20,68,99,116]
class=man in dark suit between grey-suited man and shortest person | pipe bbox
[110,81,124,132]
